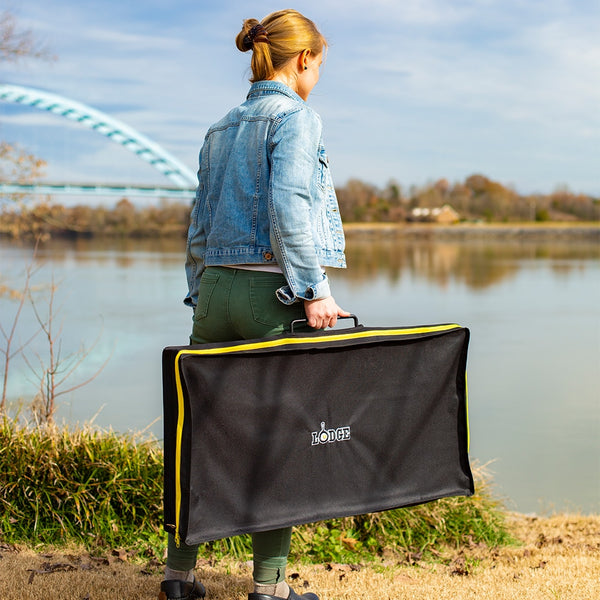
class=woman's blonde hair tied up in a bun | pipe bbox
[235,9,327,83]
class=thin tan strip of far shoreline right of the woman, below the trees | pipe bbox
[344,222,600,241]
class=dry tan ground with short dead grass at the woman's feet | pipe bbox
[0,515,600,600]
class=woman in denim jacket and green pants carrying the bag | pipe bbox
[159,10,349,600]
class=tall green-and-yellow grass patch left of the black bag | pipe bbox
[0,418,162,548]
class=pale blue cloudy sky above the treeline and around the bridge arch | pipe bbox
[0,0,600,196]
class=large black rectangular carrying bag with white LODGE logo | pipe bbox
[163,320,474,544]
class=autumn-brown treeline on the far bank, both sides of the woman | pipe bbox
[0,175,600,238]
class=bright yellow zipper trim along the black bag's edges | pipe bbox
[175,323,462,548]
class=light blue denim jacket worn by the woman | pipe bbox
[185,81,346,306]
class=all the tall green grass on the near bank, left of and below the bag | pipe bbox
[0,418,512,563]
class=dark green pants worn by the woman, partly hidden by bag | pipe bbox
[167,267,307,584]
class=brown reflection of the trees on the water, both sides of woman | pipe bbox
[11,234,600,289]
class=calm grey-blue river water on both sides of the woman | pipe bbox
[0,235,600,514]
